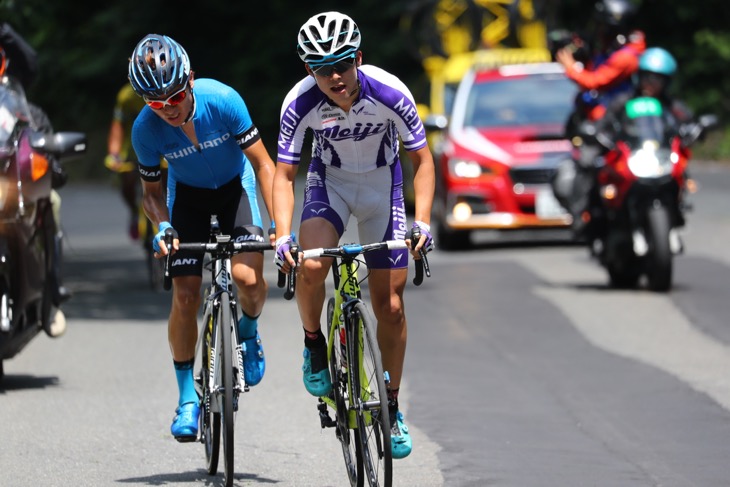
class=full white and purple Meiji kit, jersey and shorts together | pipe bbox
[278,66,427,269]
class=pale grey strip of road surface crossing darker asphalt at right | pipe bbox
[518,254,730,410]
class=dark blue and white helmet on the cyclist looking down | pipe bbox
[129,34,190,98]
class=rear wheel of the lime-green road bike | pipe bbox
[327,298,364,487]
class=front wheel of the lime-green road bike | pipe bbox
[348,302,393,487]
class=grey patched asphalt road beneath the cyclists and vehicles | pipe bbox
[0,165,730,487]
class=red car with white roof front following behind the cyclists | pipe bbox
[427,63,577,249]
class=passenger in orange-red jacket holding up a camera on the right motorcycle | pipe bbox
[555,0,646,237]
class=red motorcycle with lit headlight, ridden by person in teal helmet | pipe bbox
[581,97,718,292]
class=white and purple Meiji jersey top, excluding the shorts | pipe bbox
[278,66,426,173]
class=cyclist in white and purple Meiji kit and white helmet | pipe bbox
[274,12,435,458]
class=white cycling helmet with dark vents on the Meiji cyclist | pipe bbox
[297,12,360,66]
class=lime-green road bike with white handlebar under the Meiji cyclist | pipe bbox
[278,232,431,487]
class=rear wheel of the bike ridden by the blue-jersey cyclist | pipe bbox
[199,314,221,475]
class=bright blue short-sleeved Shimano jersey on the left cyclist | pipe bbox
[132,79,261,196]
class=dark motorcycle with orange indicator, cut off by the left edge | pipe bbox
[0,76,86,378]
